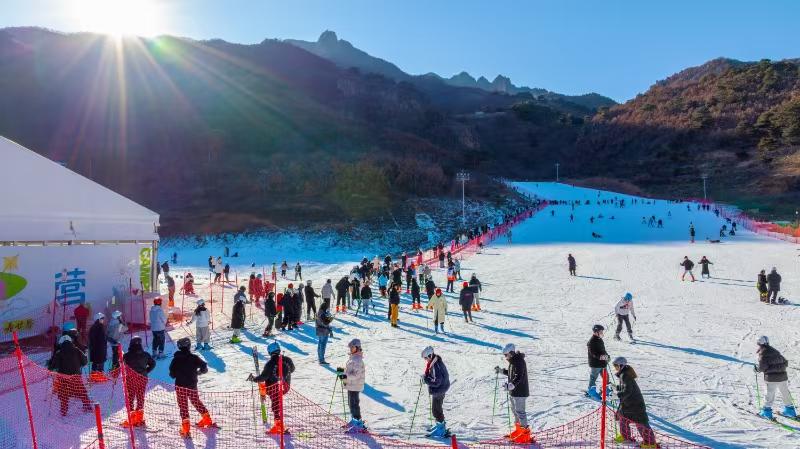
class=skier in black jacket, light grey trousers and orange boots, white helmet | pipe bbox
[494,343,532,444]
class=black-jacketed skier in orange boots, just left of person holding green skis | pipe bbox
[169,337,214,438]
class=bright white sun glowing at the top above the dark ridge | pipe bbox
[73,0,163,37]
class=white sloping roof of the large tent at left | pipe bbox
[0,137,159,242]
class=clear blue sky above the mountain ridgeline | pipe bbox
[0,0,800,101]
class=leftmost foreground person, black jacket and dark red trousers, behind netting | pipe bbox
[47,335,92,416]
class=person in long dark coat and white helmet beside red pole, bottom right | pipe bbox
[613,357,657,447]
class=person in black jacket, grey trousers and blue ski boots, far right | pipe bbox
[753,336,797,419]
